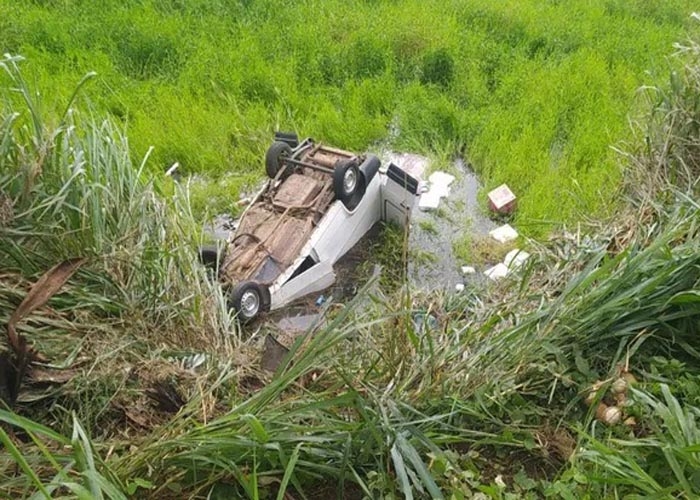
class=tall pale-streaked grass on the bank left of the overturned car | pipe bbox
[0,53,240,442]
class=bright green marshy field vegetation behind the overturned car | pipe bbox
[0,0,696,230]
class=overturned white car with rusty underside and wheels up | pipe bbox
[200,133,418,321]
